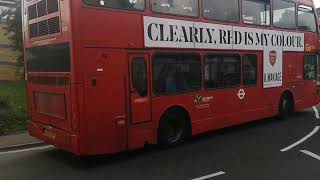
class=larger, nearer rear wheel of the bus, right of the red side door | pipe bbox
[158,111,188,147]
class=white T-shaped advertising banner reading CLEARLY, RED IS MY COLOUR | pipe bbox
[143,16,304,88]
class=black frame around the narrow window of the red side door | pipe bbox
[131,57,149,97]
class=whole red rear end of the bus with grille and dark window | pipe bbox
[23,0,78,153]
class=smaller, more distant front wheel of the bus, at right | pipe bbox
[279,94,294,119]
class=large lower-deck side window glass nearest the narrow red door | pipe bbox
[153,54,201,94]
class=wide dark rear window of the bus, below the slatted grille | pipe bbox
[27,44,70,72]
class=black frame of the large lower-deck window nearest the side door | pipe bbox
[151,52,203,96]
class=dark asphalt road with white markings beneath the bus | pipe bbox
[0,107,320,180]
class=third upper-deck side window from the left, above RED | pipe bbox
[202,0,240,22]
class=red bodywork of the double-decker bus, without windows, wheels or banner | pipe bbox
[23,0,319,155]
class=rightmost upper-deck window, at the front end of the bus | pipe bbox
[298,5,317,32]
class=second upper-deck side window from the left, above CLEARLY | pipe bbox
[152,0,198,17]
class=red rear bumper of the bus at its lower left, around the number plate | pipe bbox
[27,121,80,155]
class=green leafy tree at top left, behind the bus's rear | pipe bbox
[0,1,23,65]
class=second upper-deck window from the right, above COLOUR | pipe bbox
[273,0,297,29]
